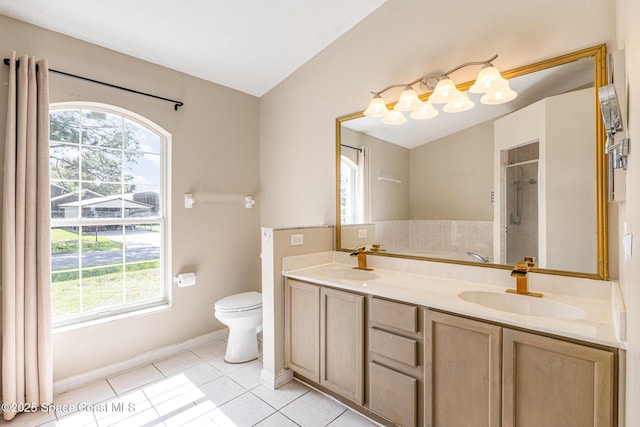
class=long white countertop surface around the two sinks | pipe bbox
[282,252,625,348]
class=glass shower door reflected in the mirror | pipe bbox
[503,159,538,265]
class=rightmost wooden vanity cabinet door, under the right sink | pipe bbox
[503,329,614,427]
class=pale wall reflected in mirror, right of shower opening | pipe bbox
[545,89,597,273]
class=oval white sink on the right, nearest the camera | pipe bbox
[458,291,587,320]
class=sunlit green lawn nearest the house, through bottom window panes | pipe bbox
[52,261,160,319]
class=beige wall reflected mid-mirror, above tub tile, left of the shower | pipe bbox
[411,118,493,221]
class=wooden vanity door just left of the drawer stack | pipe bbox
[320,288,364,405]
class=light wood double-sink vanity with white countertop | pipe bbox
[283,253,622,427]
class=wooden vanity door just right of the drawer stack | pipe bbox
[425,311,504,427]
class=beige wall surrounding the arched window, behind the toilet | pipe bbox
[0,16,260,380]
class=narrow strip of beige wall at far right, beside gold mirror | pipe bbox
[612,0,640,427]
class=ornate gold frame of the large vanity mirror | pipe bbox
[336,44,609,280]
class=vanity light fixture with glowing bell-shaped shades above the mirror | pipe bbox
[364,55,518,125]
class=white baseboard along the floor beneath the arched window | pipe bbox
[53,328,229,394]
